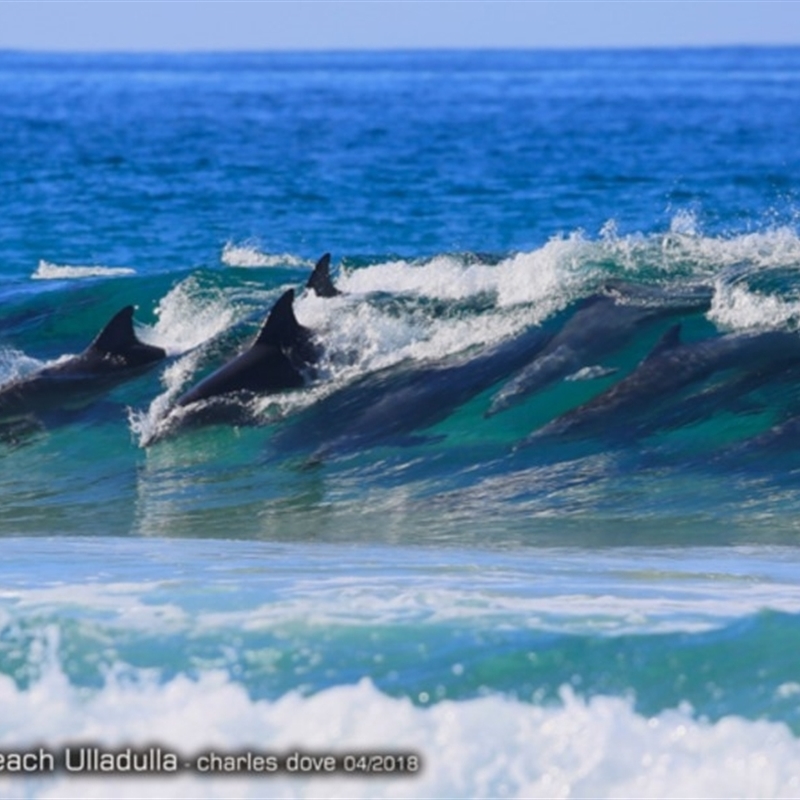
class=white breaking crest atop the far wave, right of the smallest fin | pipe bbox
[310,212,800,329]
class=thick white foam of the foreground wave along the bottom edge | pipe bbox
[0,665,800,798]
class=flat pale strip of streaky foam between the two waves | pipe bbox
[9,544,800,637]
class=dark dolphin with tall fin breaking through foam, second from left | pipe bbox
[177,289,319,406]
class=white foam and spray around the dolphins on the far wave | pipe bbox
[123,220,800,445]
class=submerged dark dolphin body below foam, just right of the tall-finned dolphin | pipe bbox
[273,328,551,462]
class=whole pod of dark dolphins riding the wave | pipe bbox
[0,253,800,464]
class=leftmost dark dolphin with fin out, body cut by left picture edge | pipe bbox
[0,306,166,420]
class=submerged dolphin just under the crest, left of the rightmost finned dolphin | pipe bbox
[485,282,711,417]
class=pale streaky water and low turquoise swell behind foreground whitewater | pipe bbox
[6,536,800,733]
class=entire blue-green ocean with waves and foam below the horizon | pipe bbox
[0,49,800,797]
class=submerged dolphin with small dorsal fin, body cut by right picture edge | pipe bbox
[522,325,800,445]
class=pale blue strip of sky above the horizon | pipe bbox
[0,0,800,51]
